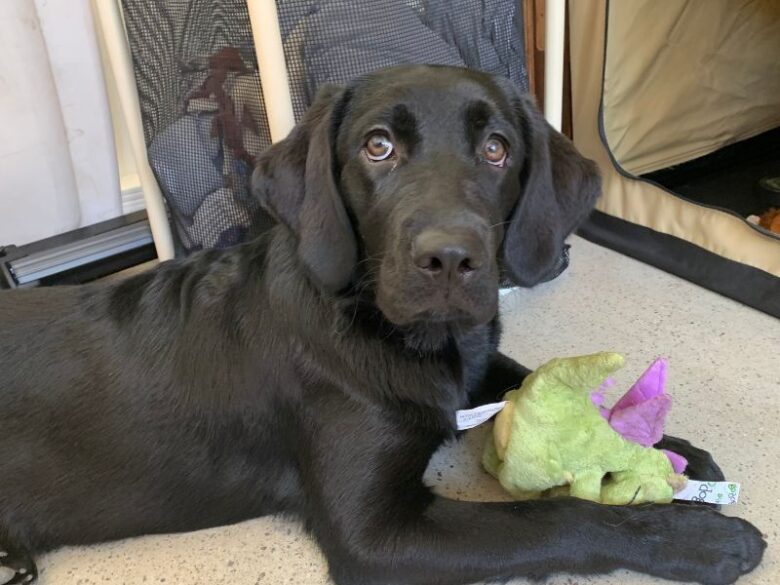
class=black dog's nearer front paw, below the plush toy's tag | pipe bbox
[640,505,766,585]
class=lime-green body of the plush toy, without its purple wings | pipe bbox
[483,353,686,504]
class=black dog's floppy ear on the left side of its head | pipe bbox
[252,85,357,292]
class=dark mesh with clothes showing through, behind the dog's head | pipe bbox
[116,0,528,254]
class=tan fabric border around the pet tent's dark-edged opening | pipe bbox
[569,0,780,277]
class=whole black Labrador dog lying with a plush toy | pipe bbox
[0,66,765,585]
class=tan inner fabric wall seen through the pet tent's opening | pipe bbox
[604,0,780,175]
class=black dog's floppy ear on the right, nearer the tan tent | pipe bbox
[502,96,601,286]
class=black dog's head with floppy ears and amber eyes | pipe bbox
[253,66,600,338]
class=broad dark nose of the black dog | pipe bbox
[412,230,484,282]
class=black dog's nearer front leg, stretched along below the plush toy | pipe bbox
[303,400,765,585]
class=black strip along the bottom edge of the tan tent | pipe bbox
[578,211,780,319]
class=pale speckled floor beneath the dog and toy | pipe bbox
[32,238,780,585]
